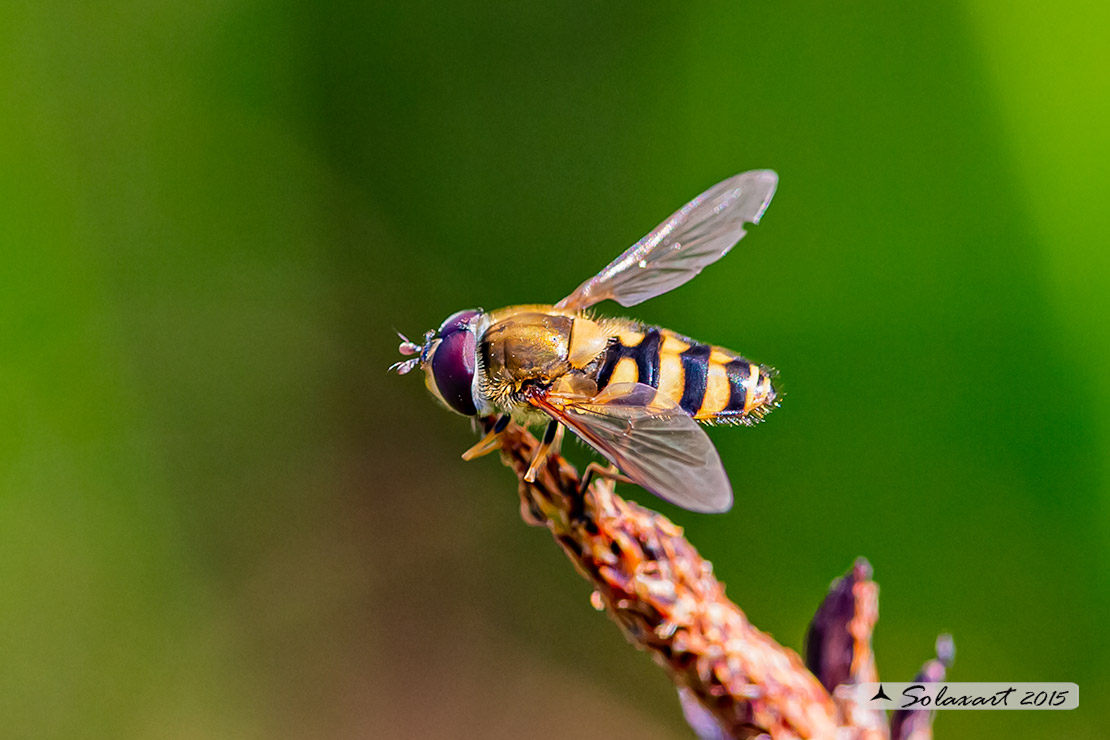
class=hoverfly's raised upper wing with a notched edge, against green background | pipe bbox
[556,170,778,310]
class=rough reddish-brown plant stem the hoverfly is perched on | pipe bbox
[487,424,874,740]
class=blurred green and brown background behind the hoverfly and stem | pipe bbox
[0,0,1110,740]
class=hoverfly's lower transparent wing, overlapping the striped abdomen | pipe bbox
[532,383,733,514]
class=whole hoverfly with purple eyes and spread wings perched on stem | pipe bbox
[391,170,778,513]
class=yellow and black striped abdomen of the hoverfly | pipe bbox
[597,326,777,424]
